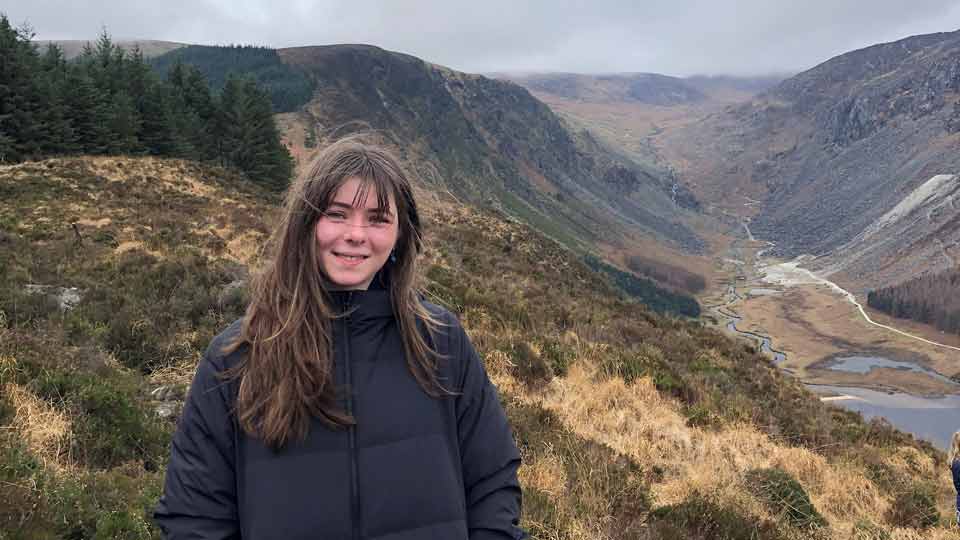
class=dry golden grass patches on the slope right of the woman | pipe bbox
[502,357,960,539]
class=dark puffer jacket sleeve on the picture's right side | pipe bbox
[450,315,527,540]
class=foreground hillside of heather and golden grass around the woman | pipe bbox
[0,158,958,540]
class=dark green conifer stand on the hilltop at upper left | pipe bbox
[0,14,293,188]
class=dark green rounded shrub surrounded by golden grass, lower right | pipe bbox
[746,467,827,529]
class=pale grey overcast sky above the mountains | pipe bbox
[0,0,960,76]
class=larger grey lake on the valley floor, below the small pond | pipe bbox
[806,384,960,450]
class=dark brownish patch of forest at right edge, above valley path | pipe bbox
[867,268,960,334]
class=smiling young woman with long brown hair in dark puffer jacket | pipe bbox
[155,139,526,540]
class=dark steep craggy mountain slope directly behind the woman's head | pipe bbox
[266,45,703,251]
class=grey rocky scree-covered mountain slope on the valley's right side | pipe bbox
[659,28,960,283]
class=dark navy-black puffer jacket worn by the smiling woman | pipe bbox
[154,290,526,540]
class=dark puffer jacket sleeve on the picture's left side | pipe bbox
[154,339,240,540]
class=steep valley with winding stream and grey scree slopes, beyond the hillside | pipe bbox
[515,40,960,466]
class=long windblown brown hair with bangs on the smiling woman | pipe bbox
[227,136,447,448]
